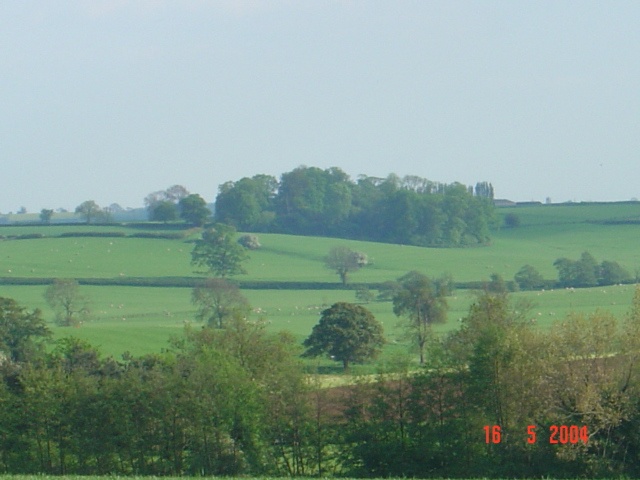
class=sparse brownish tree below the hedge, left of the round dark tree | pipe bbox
[191,278,249,328]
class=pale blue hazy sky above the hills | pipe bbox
[0,0,640,213]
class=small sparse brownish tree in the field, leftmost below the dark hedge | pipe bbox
[44,278,90,327]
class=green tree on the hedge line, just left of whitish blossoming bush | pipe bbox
[191,223,249,278]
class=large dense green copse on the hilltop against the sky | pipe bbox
[215,167,495,246]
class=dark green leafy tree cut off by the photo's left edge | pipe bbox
[0,297,51,365]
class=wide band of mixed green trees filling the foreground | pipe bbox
[0,290,640,478]
